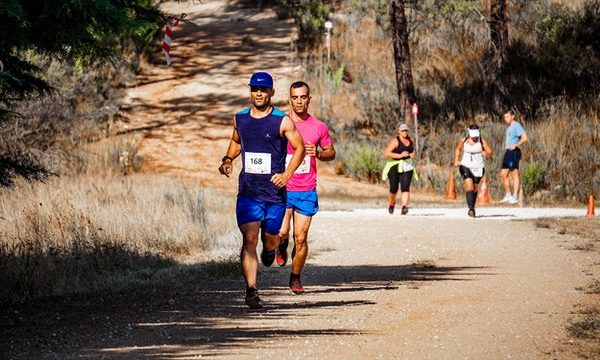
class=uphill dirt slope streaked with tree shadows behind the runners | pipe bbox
[117,1,297,188]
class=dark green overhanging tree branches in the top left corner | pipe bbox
[0,0,162,122]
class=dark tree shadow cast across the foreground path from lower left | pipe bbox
[0,265,493,359]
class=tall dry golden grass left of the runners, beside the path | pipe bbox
[0,175,234,302]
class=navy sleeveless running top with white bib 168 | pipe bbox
[235,108,288,204]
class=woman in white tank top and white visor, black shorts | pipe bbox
[454,125,492,217]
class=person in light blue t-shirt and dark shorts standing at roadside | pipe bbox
[500,110,527,204]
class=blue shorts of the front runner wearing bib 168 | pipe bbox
[235,196,285,235]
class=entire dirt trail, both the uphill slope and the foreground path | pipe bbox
[0,0,600,359]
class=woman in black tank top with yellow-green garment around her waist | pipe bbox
[382,123,419,215]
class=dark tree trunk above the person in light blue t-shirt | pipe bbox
[489,0,508,115]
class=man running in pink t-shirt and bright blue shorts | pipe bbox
[276,81,335,295]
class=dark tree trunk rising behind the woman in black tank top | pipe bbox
[390,0,416,122]
